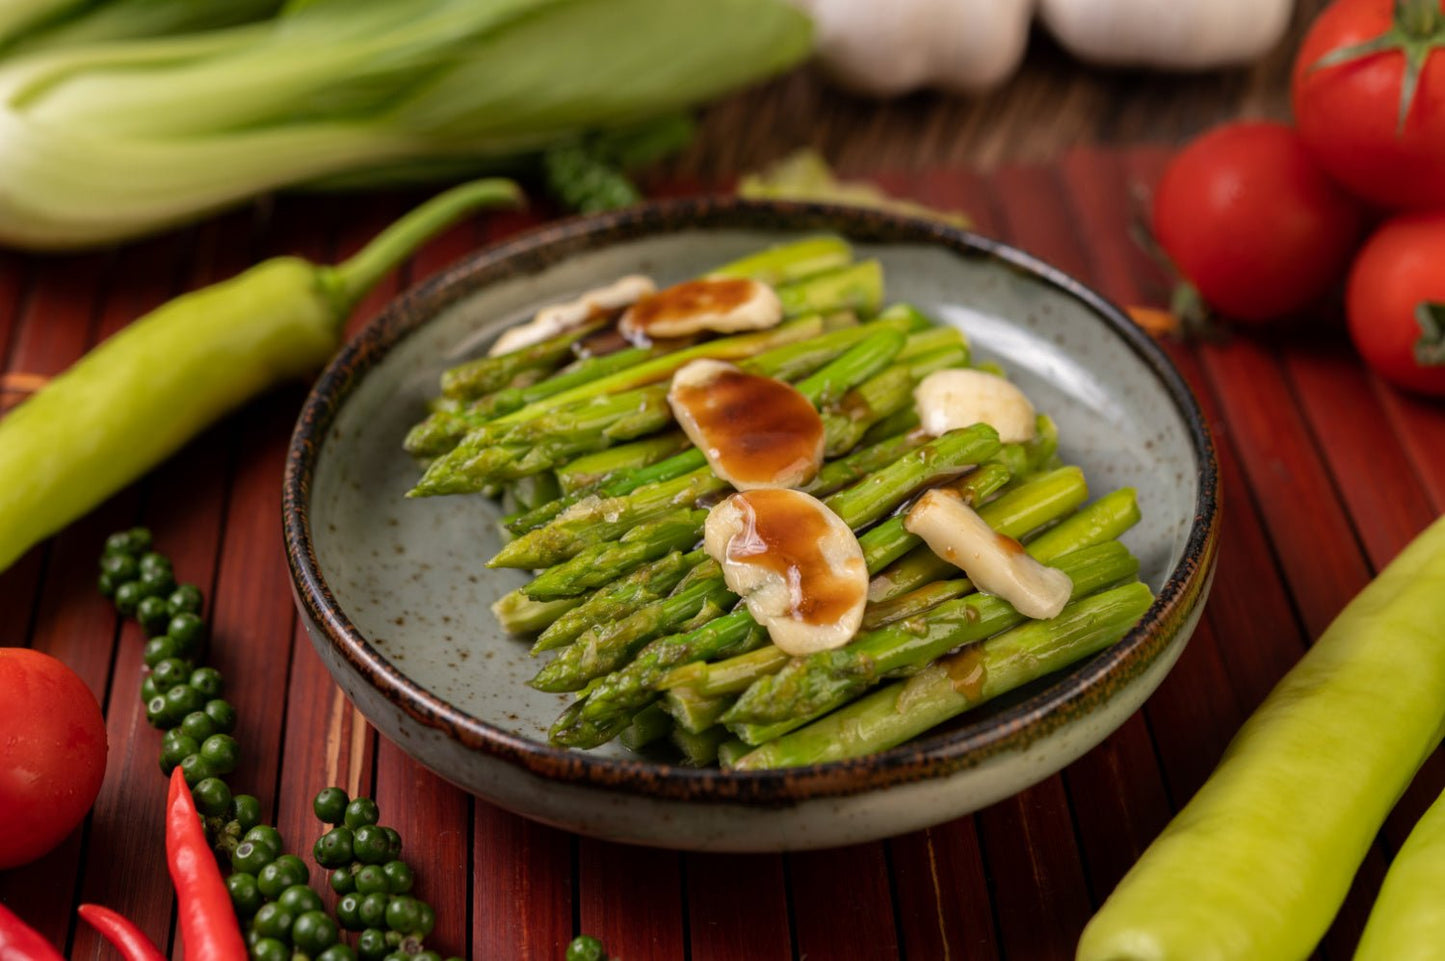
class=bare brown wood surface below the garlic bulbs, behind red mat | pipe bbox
[662,0,1328,182]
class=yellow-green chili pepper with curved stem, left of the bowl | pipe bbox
[0,179,522,569]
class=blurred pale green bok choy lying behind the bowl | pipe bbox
[0,0,811,249]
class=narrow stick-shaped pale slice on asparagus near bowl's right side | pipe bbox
[903,490,1074,619]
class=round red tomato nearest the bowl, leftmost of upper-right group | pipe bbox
[1153,123,1364,321]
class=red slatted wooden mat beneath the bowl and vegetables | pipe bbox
[8,16,1445,961]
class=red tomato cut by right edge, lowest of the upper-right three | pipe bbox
[1345,211,1445,396]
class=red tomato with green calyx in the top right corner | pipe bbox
[1292,0,1445,208]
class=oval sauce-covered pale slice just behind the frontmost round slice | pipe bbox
[668,360,824,490]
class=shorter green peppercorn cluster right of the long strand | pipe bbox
[312,788,456,961]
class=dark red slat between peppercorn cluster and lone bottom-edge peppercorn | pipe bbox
[471,799,575,961]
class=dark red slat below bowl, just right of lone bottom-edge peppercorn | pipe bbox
[578,838,684,961]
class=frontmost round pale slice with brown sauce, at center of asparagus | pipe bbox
[702,490,868,656]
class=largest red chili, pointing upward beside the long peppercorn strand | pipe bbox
[164,767,246,961]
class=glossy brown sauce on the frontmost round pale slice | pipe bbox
[727,490,858,624]
